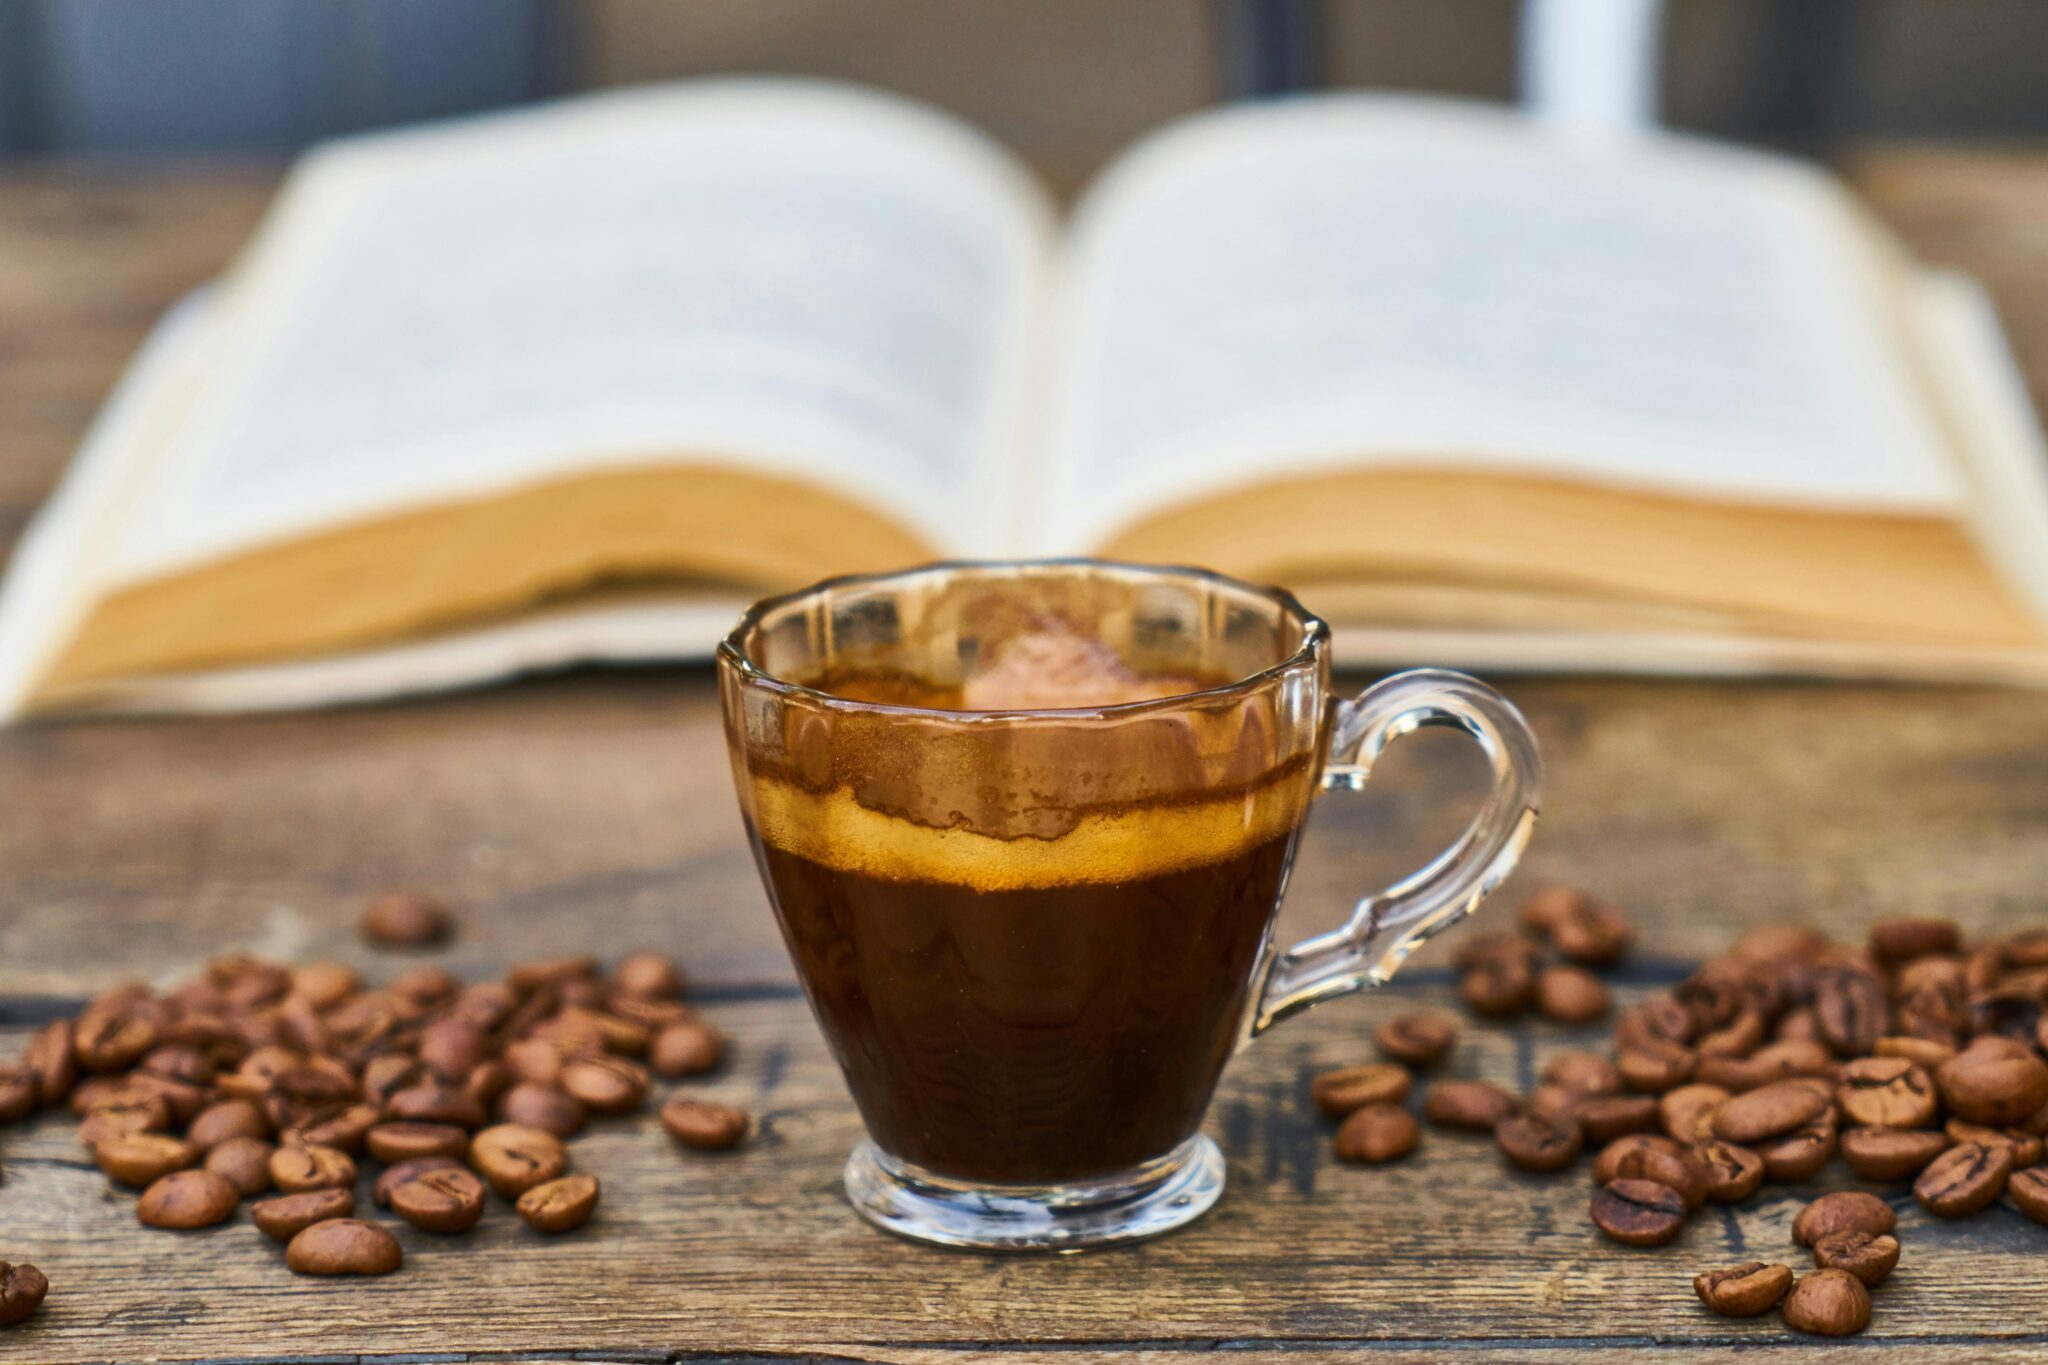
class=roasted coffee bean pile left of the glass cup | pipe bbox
[0,892,750,1326]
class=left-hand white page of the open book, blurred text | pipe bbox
[101,80,1051,581]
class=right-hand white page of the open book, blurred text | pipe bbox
[1040,96,1960,548]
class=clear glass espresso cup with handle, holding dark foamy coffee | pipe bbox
[719,561,1540,1250]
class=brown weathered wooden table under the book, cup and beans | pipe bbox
[0,149,2048,1365]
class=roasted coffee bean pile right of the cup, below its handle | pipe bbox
[1311,890,2048,1336]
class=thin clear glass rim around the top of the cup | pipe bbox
[717,555,1329,724]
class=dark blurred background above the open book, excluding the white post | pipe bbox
[0,0,2048,172]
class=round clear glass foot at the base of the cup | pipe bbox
[846,1136,1223,1252]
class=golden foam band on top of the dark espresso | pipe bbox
[752,767,1309,890]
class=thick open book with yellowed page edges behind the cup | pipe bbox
[0,80,2048,712]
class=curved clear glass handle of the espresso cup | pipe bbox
[1245,669,1542,1040]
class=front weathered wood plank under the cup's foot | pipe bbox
[0,986,2048,1361]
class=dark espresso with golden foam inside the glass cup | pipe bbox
[752,649,1307,1185]
